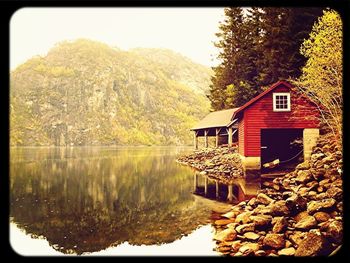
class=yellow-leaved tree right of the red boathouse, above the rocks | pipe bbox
[296,10,343,141]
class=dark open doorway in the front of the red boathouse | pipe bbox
[260,129,304,173]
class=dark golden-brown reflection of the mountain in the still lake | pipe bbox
[10,147,209,254]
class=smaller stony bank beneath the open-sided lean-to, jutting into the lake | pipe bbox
[176,147,243,184]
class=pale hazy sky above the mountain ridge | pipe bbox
[10,7,223,69]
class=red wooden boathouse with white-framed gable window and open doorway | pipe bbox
[191,81,320,178]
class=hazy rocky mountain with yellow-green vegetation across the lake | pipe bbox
[10,39,212,146]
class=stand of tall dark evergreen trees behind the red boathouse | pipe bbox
[208,7,322,110]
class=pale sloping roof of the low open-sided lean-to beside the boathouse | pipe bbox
[191,108,239,130]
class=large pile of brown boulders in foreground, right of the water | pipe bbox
[213,135,343,256]
